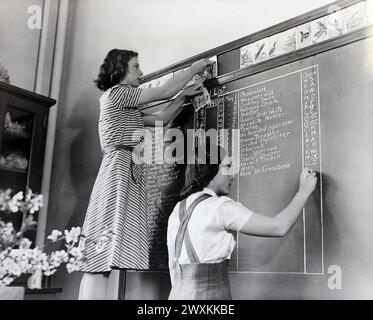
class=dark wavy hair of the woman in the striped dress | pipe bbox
[94,49,138,91]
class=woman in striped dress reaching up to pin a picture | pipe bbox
[79,49,211,299]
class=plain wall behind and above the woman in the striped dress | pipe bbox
[47,0,338,299]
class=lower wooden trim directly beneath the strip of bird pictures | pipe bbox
[207,26,373,88]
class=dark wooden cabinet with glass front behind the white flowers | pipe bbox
[0,82,56,255]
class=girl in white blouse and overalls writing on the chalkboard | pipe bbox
[167,149,317,300]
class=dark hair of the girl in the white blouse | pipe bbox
[180,145,226,200]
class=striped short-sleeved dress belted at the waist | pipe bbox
[80,84,149,272]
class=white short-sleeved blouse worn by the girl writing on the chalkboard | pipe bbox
[167,188,253,264]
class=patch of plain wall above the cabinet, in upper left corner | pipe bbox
[0,0,44,91]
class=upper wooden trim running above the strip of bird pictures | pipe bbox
[141,0,364,83]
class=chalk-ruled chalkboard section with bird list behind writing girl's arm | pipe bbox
[198,65,323,273]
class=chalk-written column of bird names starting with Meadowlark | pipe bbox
[239,85,293,176]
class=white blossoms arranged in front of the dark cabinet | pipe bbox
[0,189,84,287]
